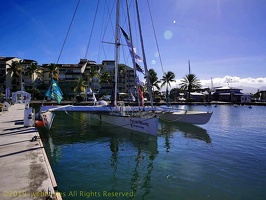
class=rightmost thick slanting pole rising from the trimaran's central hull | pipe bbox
[135,0,153,107]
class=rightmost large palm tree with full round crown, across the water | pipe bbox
[179,74,201,99]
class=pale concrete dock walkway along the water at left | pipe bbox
[0,104,60,200]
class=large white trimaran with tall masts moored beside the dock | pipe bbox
[41,0,212,128]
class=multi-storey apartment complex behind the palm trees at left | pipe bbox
[0,57,135,99]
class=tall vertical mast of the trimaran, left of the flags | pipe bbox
[114,0,120,106]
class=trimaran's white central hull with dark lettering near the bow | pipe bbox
[93,114,158,136]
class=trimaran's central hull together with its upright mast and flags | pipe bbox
[93,0,158,136]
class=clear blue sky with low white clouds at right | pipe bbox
[0,0,266,92]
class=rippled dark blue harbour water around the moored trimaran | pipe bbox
[40,105,266,200]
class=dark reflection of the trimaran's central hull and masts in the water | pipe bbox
[94,118,159,199]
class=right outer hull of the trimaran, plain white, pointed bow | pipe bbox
[156,111,212,125]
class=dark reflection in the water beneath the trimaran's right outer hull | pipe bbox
[159,121,211,143]
